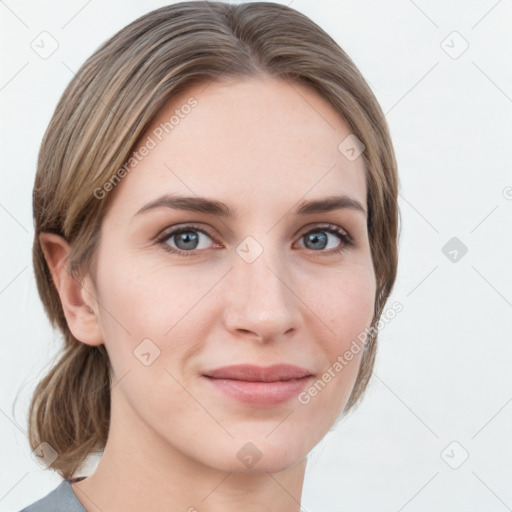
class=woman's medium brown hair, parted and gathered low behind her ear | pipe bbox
[24,1,399,478]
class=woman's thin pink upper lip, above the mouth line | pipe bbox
[203,364,312,382]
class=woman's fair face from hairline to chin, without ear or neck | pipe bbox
[87,78,376,472]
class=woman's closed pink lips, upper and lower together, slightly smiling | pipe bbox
[203,364,313,407]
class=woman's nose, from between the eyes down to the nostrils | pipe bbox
[223,244,301,343]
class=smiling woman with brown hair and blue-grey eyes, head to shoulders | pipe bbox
[19,2,398,512]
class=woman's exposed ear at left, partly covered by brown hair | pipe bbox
[39,233,103,345]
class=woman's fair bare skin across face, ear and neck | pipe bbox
[41,77,376,512]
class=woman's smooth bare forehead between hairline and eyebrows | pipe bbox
[106,77,366,218]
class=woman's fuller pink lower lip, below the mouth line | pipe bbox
[204,375,313,407]
